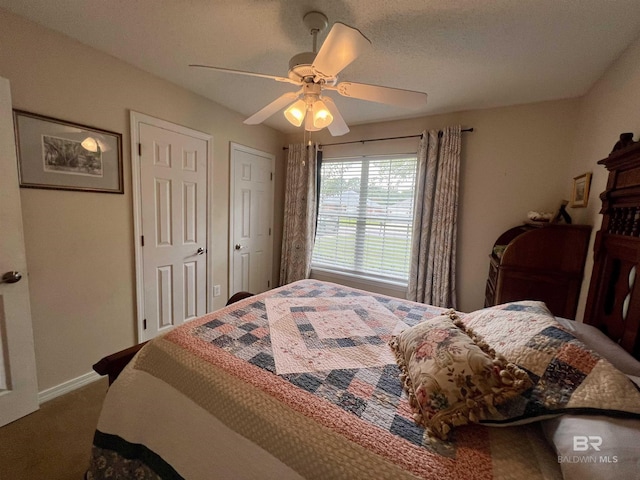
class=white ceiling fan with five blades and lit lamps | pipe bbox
[189,12,427,136]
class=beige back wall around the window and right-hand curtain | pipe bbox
[288,100,579,311]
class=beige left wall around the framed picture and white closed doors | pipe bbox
[0,10,284,391]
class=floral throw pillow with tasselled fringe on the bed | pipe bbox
[390,311,531,439]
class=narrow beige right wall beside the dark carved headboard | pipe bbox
[566,32,640,319]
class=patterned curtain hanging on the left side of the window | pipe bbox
[280,144,317,285]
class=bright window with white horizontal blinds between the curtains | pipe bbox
[312,155,417,284]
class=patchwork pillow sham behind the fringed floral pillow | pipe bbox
[462,301,640,425]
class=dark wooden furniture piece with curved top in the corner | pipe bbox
[485,223,591,319]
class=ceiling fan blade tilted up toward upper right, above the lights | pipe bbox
[311,22,371,78]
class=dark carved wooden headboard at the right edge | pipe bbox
[584,142,640,360]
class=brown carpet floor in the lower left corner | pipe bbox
[0,378,107,480]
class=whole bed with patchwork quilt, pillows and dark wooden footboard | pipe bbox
[86,143,640,480]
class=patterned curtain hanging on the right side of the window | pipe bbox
[407,126,462,308]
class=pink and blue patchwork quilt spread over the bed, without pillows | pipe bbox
[86,280,560,480]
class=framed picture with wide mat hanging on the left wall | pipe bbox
[13,110,124,193]
